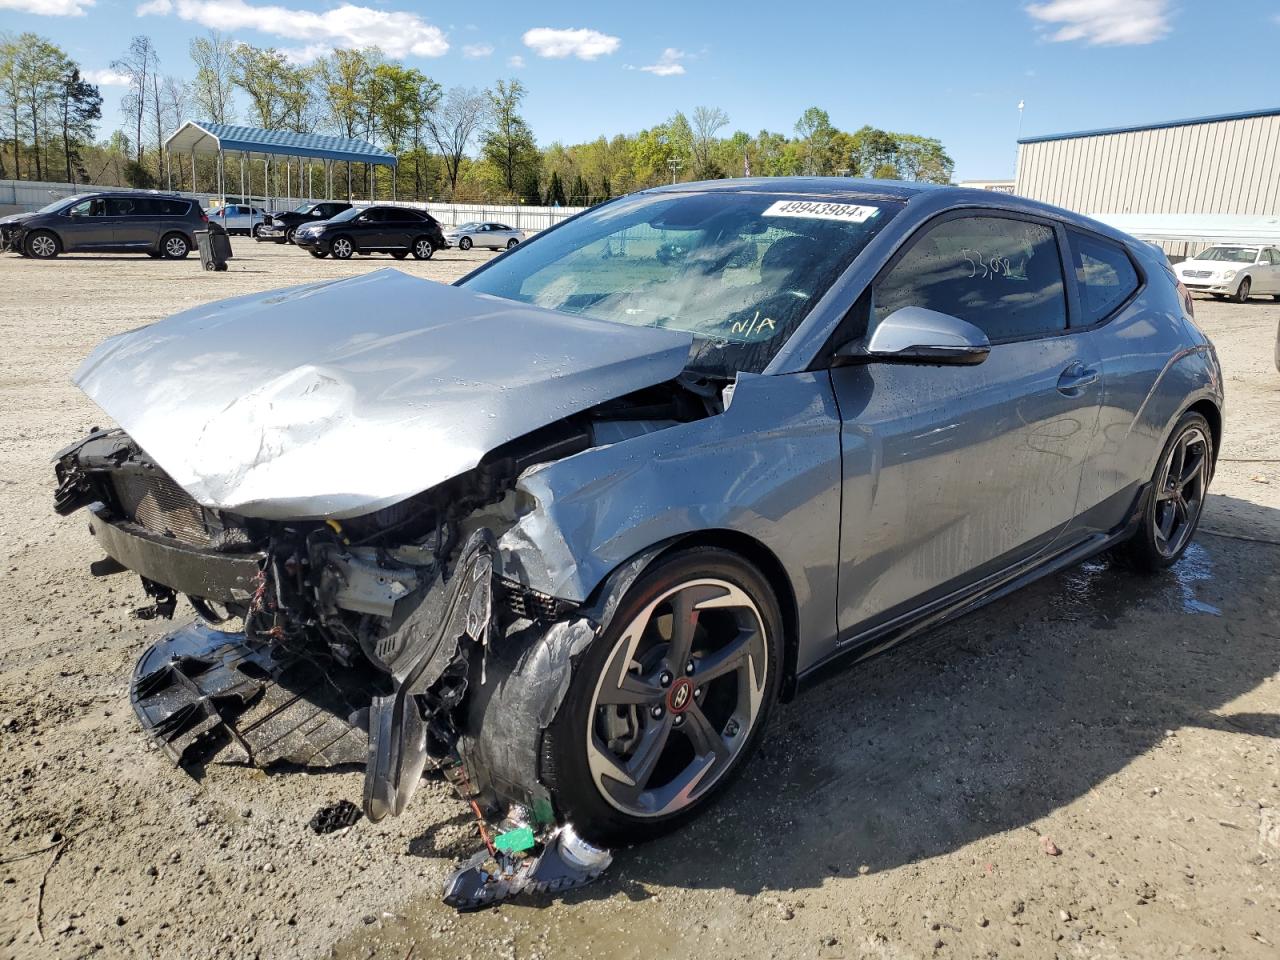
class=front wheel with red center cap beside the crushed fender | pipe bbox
[541,547,782,846]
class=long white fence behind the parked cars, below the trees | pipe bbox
[0,180,586,230]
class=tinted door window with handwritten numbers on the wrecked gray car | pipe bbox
[870,216,1066,340]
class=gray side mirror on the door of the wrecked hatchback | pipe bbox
[836,307,991,366]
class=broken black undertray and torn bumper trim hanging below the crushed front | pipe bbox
[132,530,497,820]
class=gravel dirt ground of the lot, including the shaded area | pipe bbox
[0,239,1280,960]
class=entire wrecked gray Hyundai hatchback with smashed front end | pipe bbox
[56,179,1222,906]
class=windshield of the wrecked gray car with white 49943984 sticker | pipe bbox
[460,192,901,378]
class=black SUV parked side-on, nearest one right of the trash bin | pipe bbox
[293,206,447,260]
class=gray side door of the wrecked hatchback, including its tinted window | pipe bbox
[832,211,1102,644]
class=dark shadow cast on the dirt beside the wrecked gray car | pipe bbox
[550,504,1280,901]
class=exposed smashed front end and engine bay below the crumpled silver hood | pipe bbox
[55,378,722,906]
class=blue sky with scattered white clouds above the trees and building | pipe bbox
[0,0,1280,179]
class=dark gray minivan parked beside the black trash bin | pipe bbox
[9,192,209,260]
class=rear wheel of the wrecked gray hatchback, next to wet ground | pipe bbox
[1115,411,1213,573]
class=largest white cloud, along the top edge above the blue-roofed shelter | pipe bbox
[138,0,449,58]
